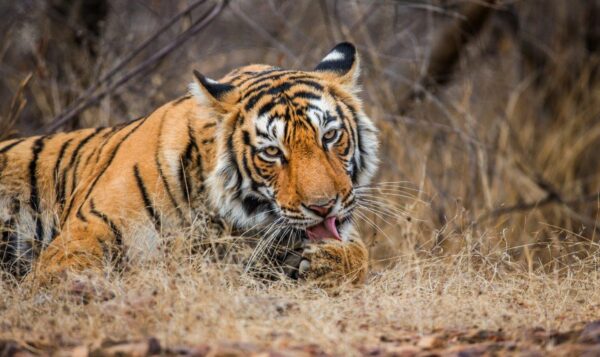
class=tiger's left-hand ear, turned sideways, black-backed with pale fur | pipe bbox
[190,71,240,112]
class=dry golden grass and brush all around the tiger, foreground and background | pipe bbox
[0,0,600,356]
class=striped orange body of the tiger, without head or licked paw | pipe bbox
[0,97,216,275]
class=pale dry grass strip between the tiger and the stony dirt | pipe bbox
[0,239,600,355]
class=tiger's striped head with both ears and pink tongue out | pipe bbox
[191,43,378,240]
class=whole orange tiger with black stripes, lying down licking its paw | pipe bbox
[0,43,378,287]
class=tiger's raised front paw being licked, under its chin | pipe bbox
[298,240,369,289]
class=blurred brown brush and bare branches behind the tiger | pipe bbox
[0,0,600,271]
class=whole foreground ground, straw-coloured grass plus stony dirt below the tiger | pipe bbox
[0,248,600,356]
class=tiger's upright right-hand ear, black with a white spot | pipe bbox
[315,42,360,88]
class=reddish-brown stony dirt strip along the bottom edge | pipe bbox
[0,321,600,357]
